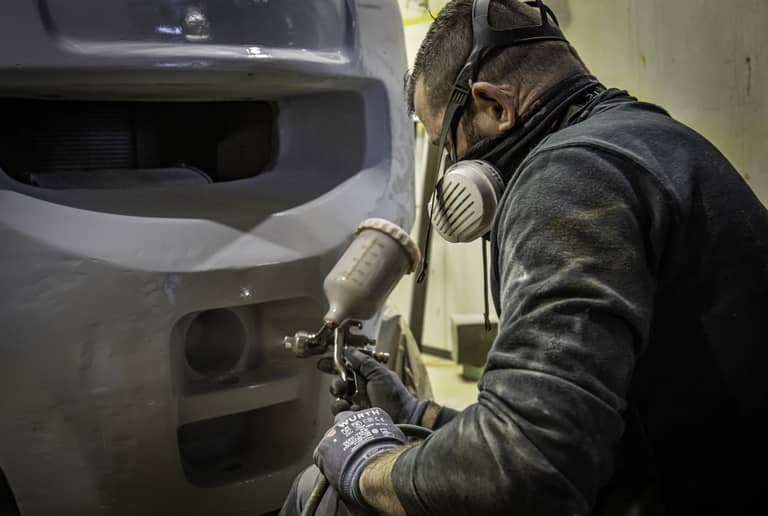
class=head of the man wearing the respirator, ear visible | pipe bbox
[407,0,587,156]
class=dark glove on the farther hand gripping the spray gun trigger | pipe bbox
[331,348,427,425]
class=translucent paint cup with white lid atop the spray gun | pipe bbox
[323,218,420,327]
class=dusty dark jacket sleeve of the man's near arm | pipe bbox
[392,146,667,516]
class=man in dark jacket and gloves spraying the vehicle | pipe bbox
[284,0,768,516]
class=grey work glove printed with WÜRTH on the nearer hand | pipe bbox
[313,407,405,508]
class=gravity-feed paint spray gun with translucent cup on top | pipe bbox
[283,219,420,409]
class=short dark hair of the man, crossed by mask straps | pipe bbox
[406,0,586,113]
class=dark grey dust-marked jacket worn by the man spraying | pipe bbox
[393,90,768,516]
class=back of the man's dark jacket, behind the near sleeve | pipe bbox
[533,91,768,514]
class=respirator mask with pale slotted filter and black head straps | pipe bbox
[425,0,567,245]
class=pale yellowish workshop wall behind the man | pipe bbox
[393,0,768,349]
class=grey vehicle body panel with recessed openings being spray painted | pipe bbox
[0,0,413,515]
